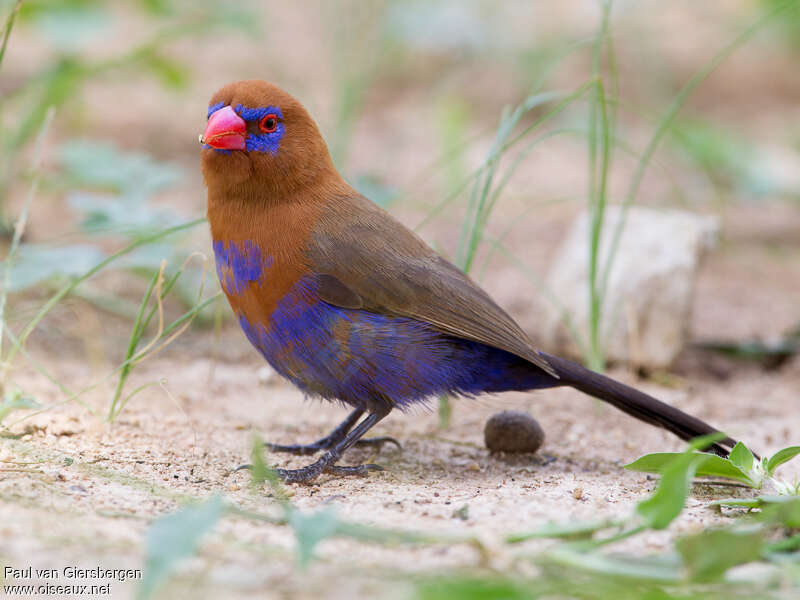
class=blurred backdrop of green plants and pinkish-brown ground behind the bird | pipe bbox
[0,0,800,598]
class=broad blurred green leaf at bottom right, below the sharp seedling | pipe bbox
[675,529,764,581]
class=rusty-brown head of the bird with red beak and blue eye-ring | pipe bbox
[200,79,339,201]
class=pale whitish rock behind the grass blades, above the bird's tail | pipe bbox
[537,206,719,368]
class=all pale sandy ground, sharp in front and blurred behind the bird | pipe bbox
[0,2,800,599]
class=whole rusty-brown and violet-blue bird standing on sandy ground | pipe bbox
[199,80,736,483]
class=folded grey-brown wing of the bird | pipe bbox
[308,197,556,377]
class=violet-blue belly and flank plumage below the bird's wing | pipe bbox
[234,275,556,409]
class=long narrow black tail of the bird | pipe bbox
[540,352,736,456]
